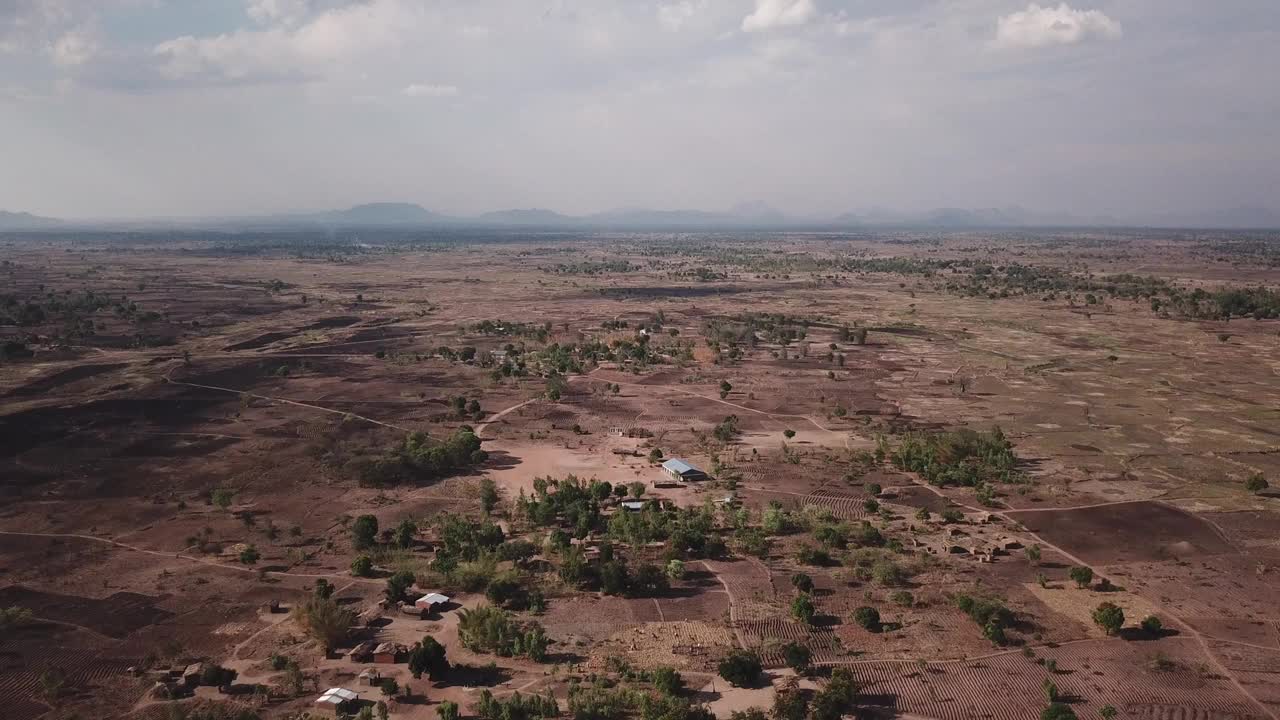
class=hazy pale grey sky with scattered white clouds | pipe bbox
[0,0,1280,218]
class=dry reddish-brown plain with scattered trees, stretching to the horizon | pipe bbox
[0,232,1280,720]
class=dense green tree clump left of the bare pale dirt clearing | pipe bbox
[353,425,489,487]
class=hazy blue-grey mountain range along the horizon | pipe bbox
[0,202,1280,231]
